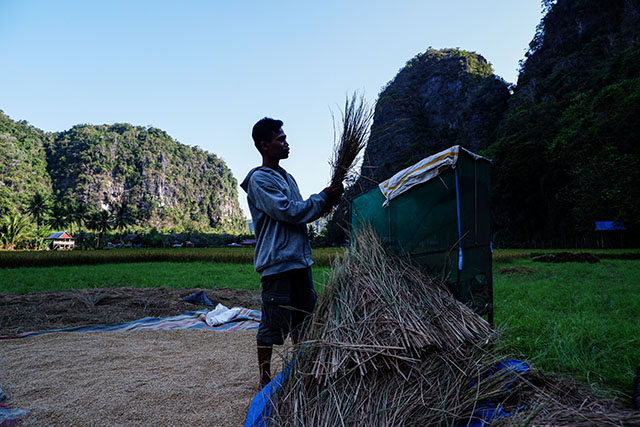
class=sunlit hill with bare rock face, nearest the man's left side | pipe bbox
[47,124,246,231]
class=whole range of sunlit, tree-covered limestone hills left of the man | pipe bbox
[0,114,247,232]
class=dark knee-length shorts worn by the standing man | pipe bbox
[256,267,317,345]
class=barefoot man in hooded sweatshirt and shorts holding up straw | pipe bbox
[240,117,343,387]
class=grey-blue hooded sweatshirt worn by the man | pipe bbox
[240,166,328,276]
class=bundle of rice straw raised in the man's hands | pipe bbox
[329,92,373,185]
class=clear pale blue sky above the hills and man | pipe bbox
[0,0,542,219]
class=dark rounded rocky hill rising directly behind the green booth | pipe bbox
[356,49,509,192]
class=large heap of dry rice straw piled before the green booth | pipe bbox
[271,229,640,426]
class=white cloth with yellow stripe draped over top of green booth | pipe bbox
[378,145,484,207]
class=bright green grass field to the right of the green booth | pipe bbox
[494,259,640,394]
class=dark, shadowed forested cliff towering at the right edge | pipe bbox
[484,0,640,247]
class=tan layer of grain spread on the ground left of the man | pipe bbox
[0,330,288,426]
